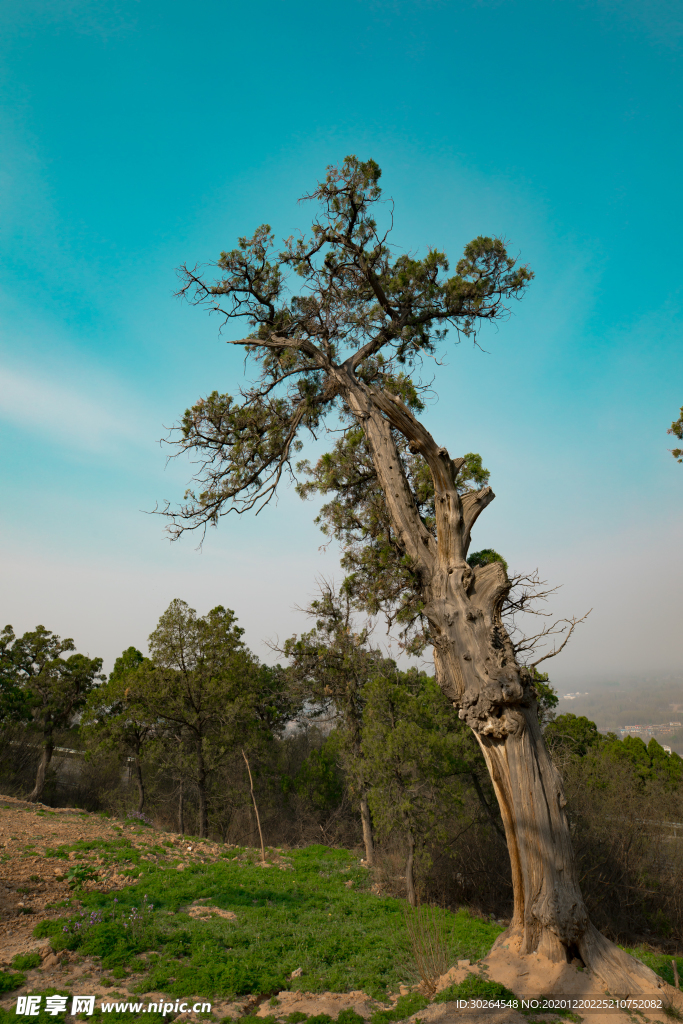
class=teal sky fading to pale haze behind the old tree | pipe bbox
[0,0,683,690]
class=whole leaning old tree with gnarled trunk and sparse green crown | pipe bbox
[167,157,655,991]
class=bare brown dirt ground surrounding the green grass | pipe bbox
[0,797,683,1024]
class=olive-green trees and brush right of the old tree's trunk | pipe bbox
[546,714,683,942]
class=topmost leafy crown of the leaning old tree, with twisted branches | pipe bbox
[171,156,532,536]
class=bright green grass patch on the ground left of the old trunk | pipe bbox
[34,840,501,998]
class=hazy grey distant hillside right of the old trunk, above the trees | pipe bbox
[557,675,683,756]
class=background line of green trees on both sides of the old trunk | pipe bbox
[0,589,683,938]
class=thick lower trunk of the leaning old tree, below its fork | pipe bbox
[427,544,657,993]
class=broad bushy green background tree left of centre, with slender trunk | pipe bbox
[96,600,296,836]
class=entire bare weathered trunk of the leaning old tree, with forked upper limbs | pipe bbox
[338,373,658,993]
